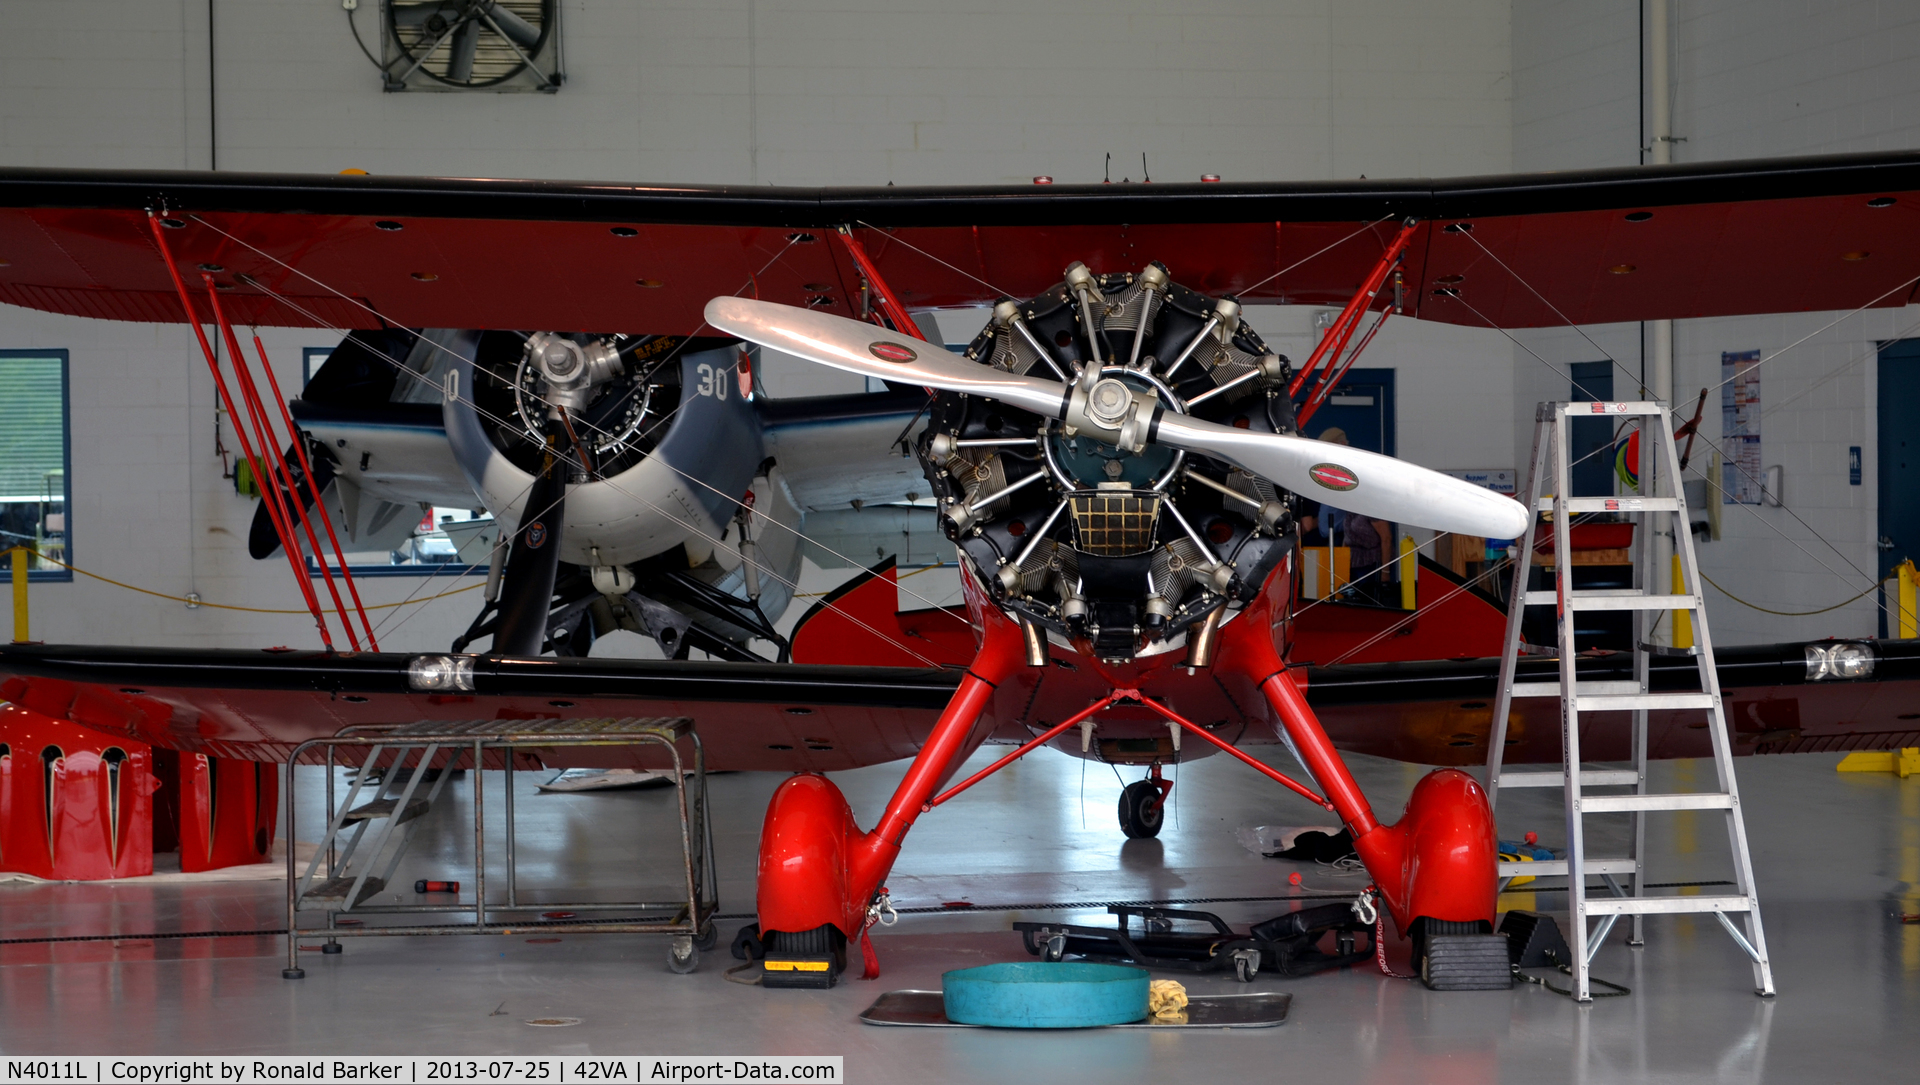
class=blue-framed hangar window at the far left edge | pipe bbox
[0,350,73,580]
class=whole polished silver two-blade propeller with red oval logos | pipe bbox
[707,298,1528,540]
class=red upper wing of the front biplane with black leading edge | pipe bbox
[0,152,1920,334]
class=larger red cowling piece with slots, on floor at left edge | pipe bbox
[0,705,156,881]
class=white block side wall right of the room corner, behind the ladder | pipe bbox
[1513,0,1920,643]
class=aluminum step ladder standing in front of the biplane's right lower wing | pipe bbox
[1486,403,1774,1002]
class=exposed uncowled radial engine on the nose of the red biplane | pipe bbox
[916,263,1296,661]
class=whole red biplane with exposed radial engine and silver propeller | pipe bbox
[0,154,1920,990]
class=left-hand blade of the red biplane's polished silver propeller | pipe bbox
[707,298,1068,419]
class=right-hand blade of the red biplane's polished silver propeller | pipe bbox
[1152,411,1526,540]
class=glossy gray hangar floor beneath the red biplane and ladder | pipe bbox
[0,753,1920,1085]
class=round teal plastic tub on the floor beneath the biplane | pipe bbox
[941,960,1148,1029]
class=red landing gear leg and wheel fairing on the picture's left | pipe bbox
[756,591,1025,977]
